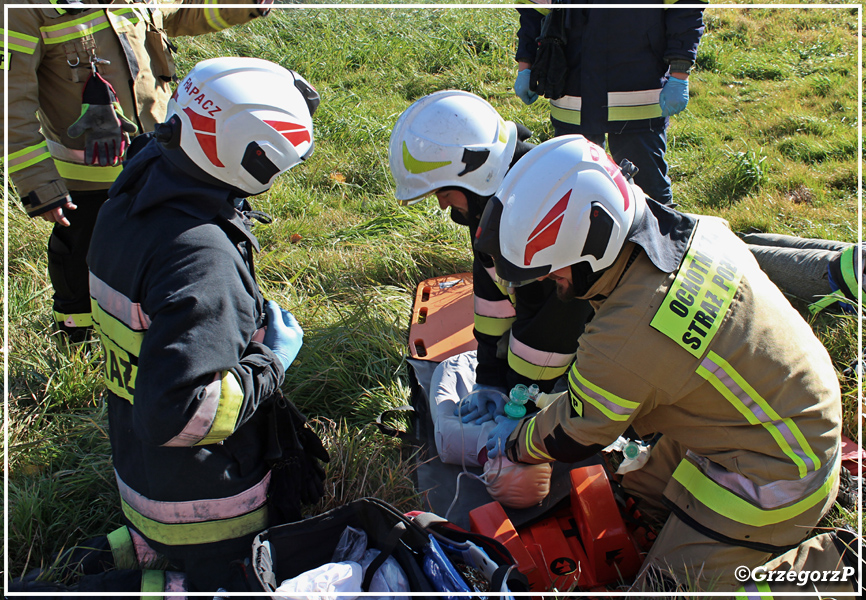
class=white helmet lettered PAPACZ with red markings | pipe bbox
[157,57,319,195]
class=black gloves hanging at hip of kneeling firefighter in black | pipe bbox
[265,393,331,523]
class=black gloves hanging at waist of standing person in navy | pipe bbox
[529,8,568,100]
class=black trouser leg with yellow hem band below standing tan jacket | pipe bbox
[48,190,108,342]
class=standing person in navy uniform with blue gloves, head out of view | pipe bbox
[514,0,704,204]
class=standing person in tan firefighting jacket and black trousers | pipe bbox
[4,0,271,342]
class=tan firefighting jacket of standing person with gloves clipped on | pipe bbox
[3,0,260,216]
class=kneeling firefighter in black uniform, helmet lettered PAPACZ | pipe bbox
[88,57,328,591]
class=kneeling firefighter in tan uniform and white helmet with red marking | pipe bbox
[476,135,856,591]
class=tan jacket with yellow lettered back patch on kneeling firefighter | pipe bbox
[510,219,842,547]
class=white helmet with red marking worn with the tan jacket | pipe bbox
[476,135,645,287]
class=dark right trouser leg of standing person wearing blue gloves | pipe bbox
[607,130,673,204]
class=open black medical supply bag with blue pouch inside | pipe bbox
[252,498,528,598]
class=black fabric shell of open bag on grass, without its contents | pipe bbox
[253,498,529,592]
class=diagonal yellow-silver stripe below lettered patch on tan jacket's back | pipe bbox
[697,351,821,478]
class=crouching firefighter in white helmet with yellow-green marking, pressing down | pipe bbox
[389,90,590,424]
